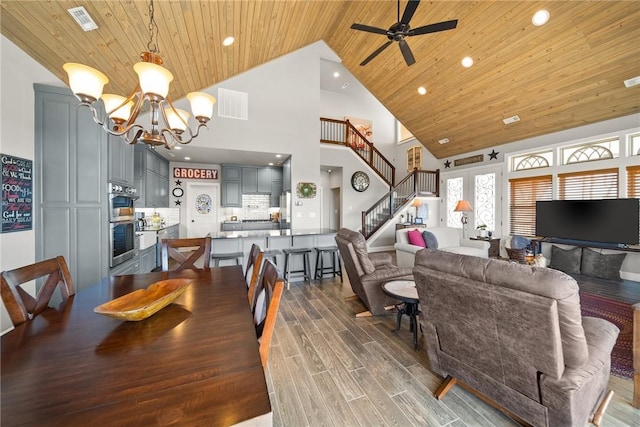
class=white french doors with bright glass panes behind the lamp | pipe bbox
[441,167,502,237]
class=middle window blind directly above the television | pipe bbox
[558,168,618,200]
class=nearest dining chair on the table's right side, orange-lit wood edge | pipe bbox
[252,260,284,368]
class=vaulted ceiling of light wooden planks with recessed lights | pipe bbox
[0,0,640,158]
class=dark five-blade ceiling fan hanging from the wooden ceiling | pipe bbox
[351,0,458,66]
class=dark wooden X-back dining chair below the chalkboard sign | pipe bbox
[0,256,75,326]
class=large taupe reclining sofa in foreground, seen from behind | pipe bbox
[413,249,619,426]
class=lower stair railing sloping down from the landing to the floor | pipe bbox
[362,169,440,239]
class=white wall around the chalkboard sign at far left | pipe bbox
[0,35,64,331]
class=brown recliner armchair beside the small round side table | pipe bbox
[336,228,413,317]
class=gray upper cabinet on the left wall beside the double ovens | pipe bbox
[134,145,169,208]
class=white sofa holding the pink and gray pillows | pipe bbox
[393,227,490,267]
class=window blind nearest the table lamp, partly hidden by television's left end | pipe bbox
[509,175,553,236]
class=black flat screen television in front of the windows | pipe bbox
[536,199,640,245]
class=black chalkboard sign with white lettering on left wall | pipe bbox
[0,154,33,233]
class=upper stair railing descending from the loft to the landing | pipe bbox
[320,117,396,187]
